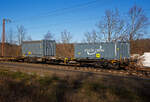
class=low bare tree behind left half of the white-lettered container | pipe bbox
[83,30,99,43]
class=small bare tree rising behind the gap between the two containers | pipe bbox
[61,30,72,43]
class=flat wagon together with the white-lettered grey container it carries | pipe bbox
[74,42,130,67]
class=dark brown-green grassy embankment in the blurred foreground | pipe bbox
[0,70,150,102]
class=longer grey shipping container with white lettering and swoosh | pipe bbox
[74,42,130,60]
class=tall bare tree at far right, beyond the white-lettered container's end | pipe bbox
[127,5,149,41]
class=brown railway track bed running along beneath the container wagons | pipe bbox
[0,62,150,79]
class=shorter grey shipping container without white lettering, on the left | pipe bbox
[22,40,56,57]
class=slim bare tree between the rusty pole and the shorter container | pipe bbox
[17,25,26,45]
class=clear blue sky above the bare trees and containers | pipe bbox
[0,0,150,41]
